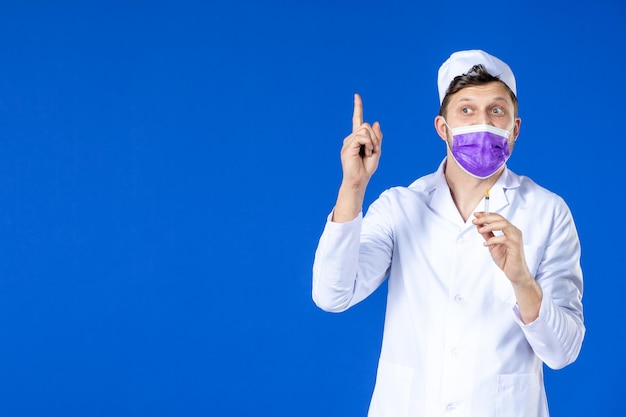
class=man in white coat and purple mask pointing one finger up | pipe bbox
[313,50,585,417]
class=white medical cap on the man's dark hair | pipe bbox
[437,49,517,103]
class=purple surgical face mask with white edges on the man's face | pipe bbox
[446,123,511,179]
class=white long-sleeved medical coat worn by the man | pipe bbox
[313,160,585,417]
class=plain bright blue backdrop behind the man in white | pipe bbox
[0,0,626,417]
